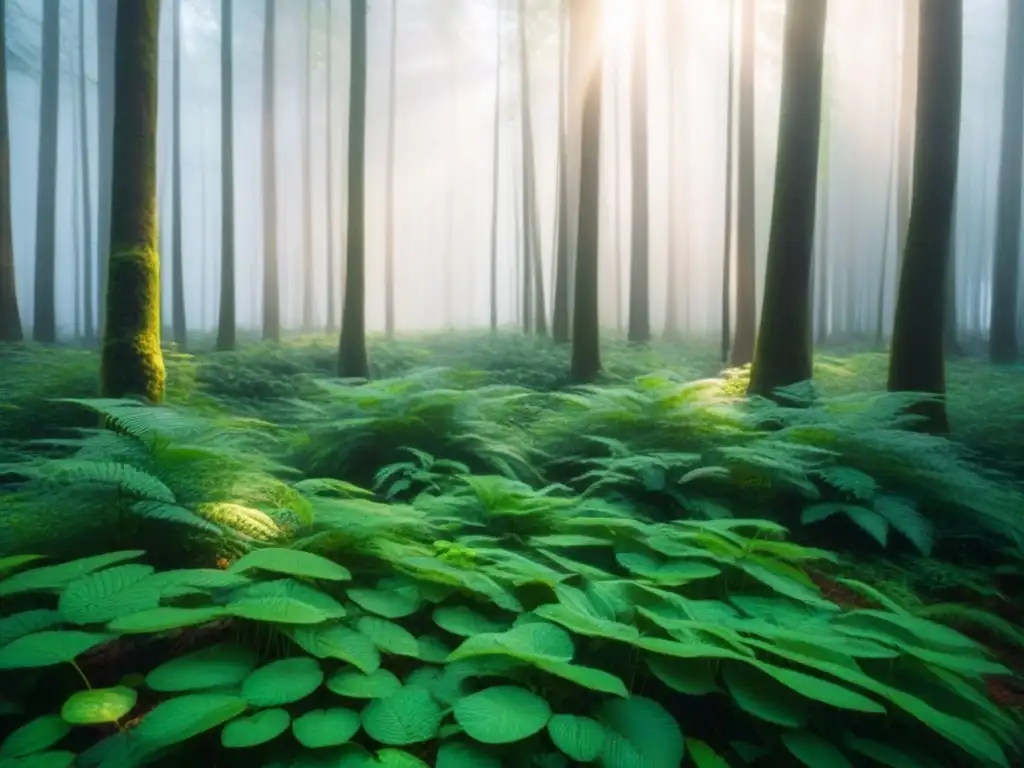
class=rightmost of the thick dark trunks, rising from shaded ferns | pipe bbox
[889,0,964,432]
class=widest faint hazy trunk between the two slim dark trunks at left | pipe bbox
[260,0,281,341]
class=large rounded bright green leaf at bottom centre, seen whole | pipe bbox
[453,685,551,744]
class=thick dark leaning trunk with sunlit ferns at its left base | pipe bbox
[750,0,828,396]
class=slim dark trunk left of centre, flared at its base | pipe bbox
[338,0,370,379]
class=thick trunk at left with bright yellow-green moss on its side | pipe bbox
[99,0,164,402]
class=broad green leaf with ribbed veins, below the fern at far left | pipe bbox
[57,563,160,625]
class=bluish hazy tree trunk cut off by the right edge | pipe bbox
[989,0,1024,362]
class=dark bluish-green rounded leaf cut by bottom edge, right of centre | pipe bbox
[597,696,686,768]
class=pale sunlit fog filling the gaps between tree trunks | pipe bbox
[7,0,1019,335]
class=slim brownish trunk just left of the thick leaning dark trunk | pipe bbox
[730,0,757,366]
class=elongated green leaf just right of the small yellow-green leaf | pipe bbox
[132,693,247,754]
